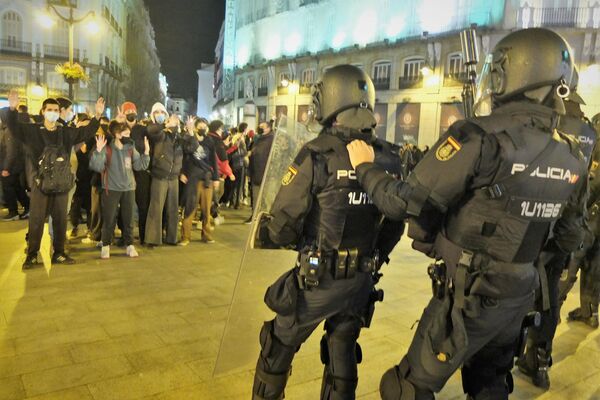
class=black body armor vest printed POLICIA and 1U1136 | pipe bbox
[442,115,585,263]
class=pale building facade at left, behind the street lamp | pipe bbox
[0,0,160,115]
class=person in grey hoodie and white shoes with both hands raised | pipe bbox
[90,120,150,259]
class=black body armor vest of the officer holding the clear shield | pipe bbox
[304,133,400,256]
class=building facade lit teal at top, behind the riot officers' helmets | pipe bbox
[217,0,600,146]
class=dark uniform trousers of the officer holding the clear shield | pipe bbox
[253,272,373,400]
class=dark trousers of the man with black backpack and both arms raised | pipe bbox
[27,185,69,256]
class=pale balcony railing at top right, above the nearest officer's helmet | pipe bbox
[517,4,600,28]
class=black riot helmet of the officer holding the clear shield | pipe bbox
[312,64,377,130]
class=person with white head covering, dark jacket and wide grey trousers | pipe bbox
[145,103,183,247]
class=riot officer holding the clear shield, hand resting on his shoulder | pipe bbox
[253,65,403,399]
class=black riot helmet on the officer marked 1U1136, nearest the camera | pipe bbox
[475,28,574,115]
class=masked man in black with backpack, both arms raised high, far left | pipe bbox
[7,91,104,269]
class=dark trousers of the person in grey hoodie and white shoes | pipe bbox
[102,190,135,246]
